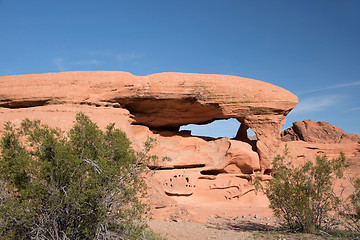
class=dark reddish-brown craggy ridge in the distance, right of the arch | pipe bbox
[281,120,360,143]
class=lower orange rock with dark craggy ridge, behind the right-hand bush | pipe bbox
[280,120,360,187]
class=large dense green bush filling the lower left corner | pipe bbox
[0,113,156,239]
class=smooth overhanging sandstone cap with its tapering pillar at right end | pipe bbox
[0,72,298,172]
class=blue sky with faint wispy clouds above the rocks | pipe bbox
[0,0,360,135]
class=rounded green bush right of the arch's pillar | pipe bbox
[263,151,346,233]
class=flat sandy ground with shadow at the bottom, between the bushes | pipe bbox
[149,216,338,240]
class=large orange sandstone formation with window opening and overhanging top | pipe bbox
[0,72,298,220]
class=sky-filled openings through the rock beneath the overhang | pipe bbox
[179,118,256,140]
